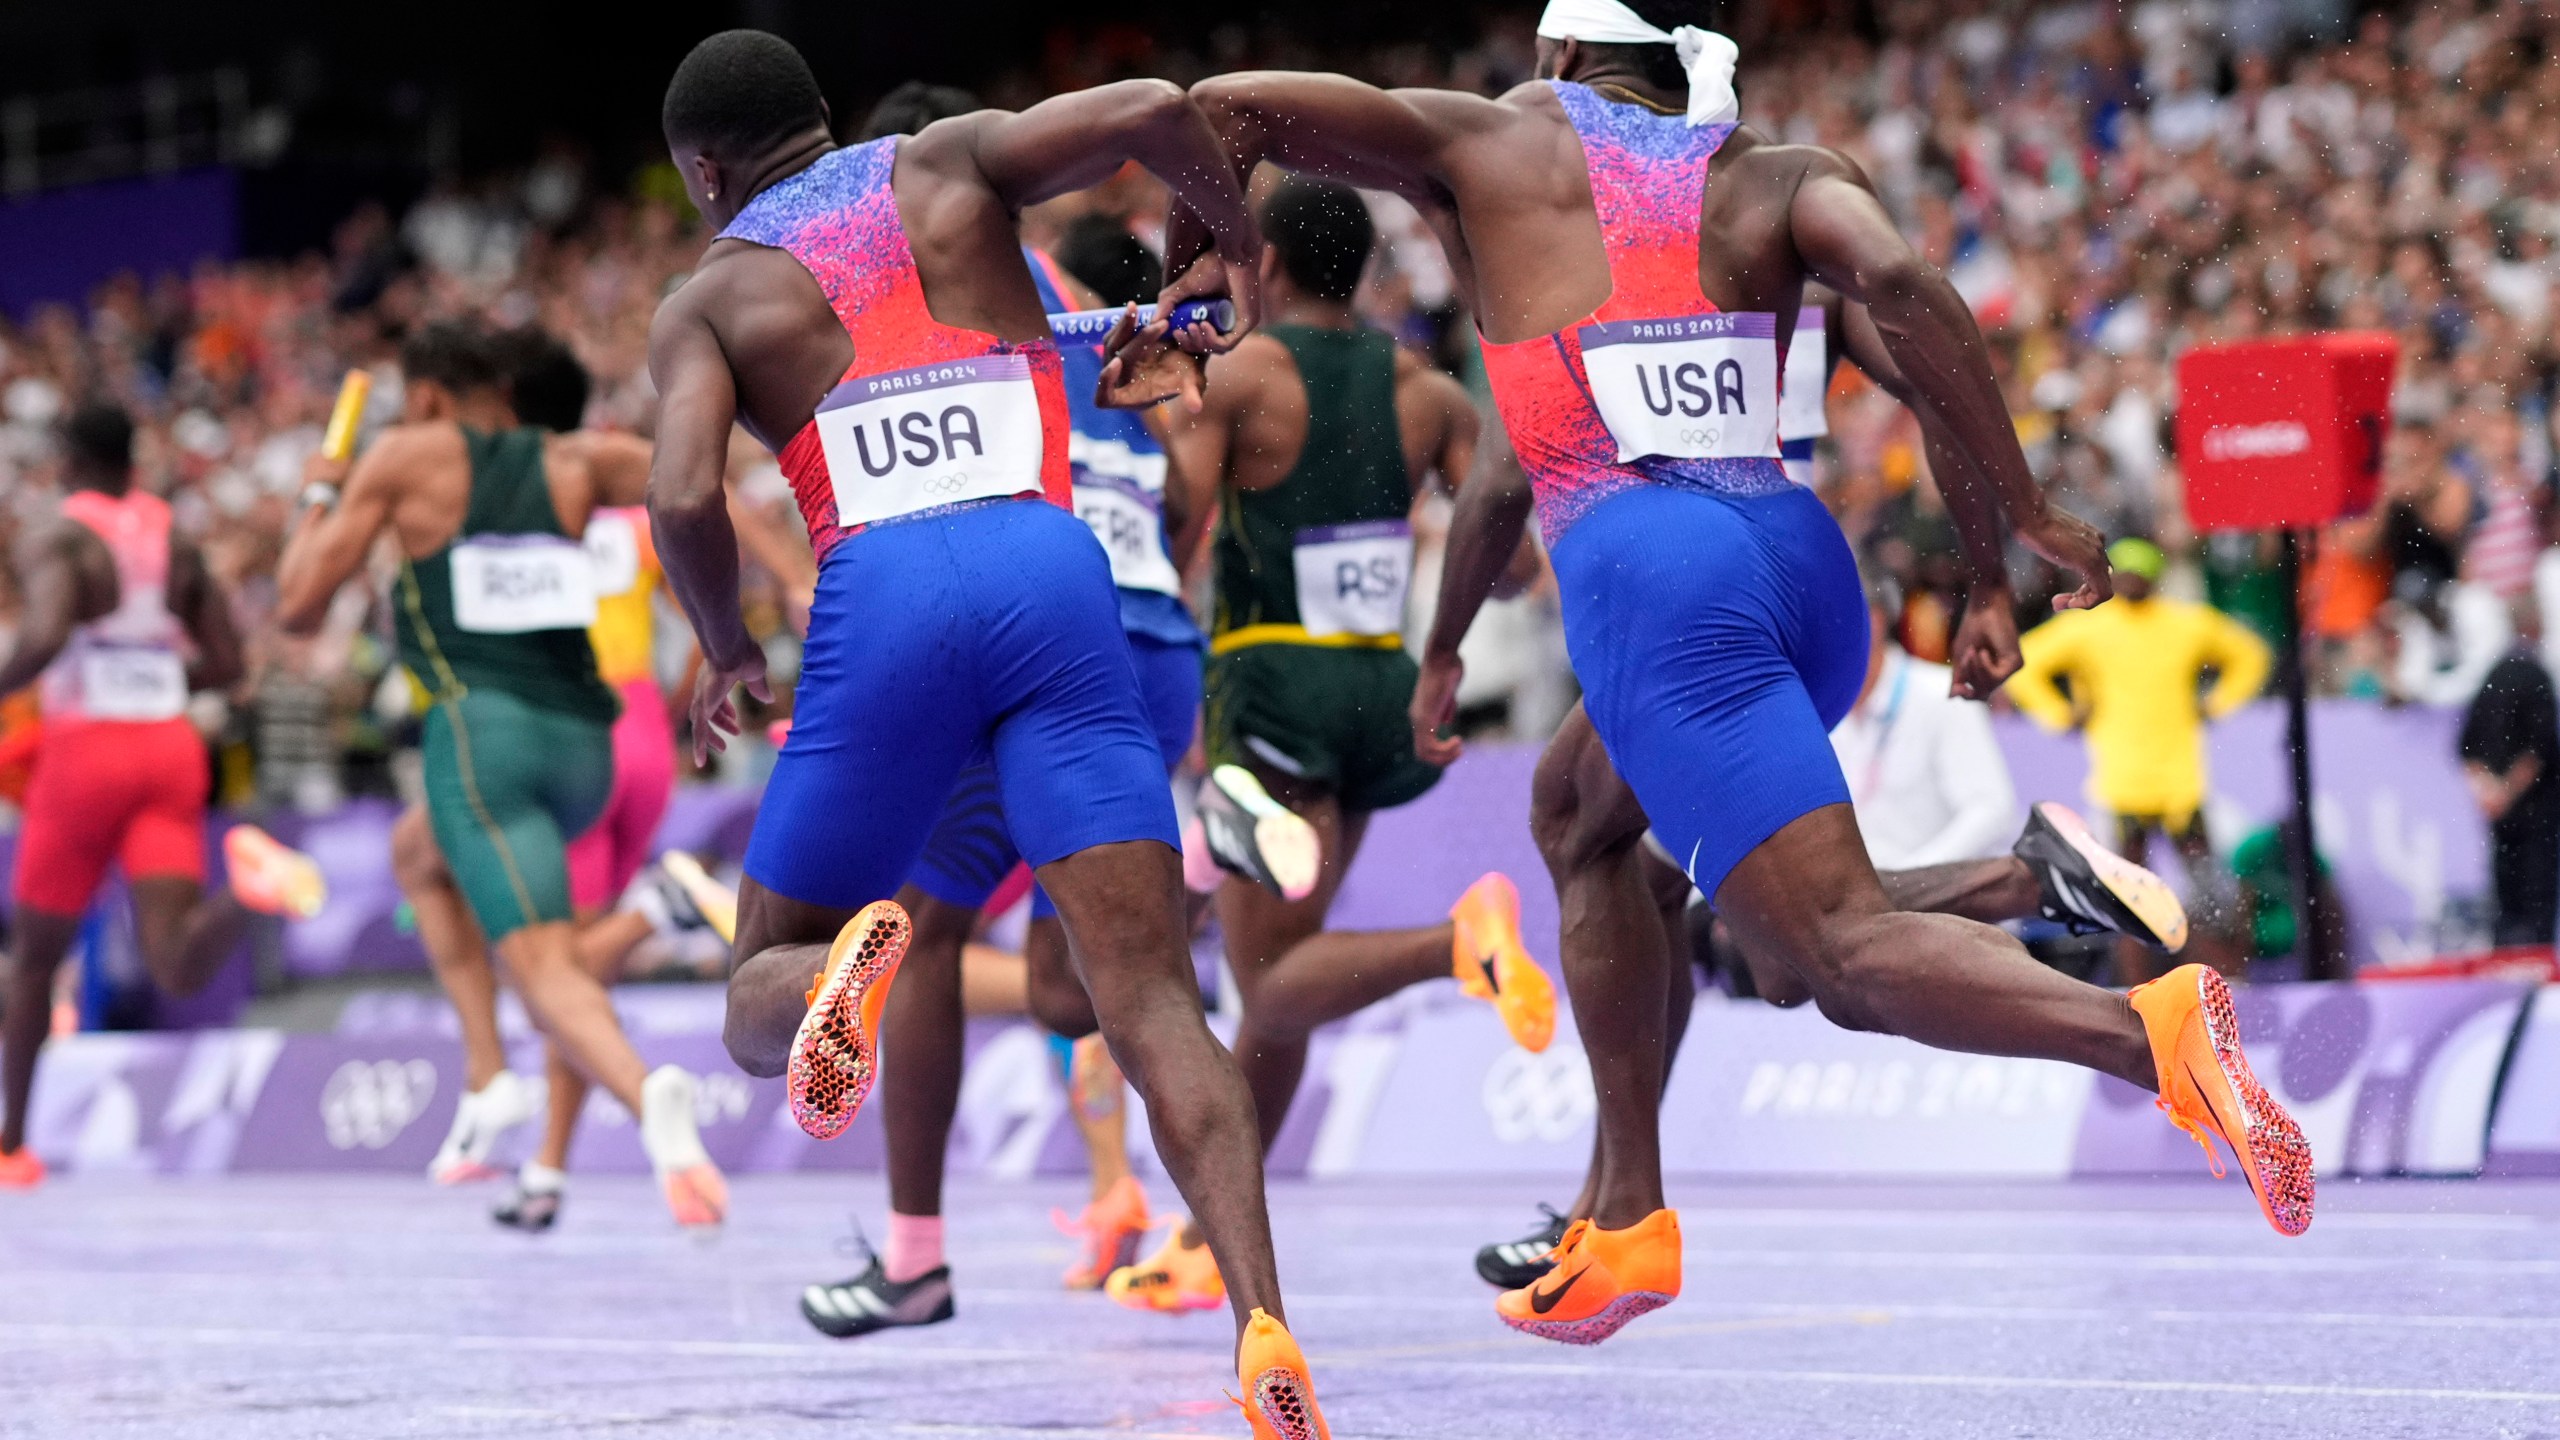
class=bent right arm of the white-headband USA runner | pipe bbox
[1787,151,2112,610]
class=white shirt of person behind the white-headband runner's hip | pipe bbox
[1830,646,2017,871]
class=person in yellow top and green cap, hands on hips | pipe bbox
[2010,541,2273,981]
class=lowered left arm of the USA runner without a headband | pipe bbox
[648,293,773,764]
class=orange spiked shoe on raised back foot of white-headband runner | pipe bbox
[2127,966,2317,1235]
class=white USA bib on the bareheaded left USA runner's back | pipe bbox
[817,354,1042,525]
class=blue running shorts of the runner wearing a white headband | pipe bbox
[1554,484,1866,902]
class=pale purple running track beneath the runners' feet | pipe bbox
[0,1176,2560,1440]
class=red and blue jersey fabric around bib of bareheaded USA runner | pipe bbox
[719,136,1070,561]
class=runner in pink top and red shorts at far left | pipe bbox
[0,402,325,1189]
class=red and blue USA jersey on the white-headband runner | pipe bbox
[1485,79,1789,546]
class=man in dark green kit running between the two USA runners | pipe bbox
[1108,177,1556,1309]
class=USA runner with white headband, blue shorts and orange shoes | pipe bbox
[1172,0,2312,1343]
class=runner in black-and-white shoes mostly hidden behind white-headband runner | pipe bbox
[1475,287,2186,1289]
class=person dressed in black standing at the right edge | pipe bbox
[2460,600,2560,945]
